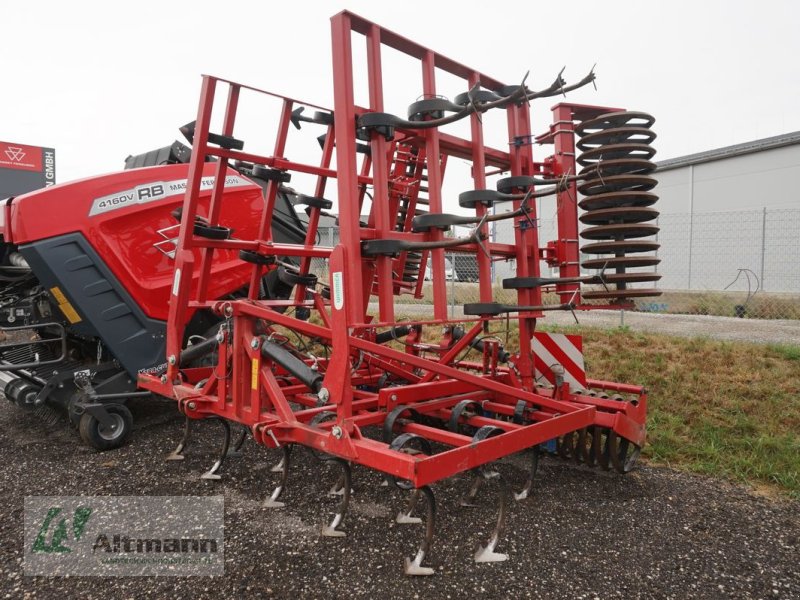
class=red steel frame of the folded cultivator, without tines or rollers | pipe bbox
[139,12,646,487]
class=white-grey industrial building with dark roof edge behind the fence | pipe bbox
[494,131,800,293]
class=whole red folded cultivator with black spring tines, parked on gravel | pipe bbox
[139,12,654,575]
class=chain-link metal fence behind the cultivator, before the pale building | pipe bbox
[315,208,800,319]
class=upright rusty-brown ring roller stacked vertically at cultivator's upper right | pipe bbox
[575,111,661,301]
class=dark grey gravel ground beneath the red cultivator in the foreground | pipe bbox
[0,401,800,599]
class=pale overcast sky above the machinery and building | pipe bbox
[0,0,800,188]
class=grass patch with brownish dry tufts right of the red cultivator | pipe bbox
[550,327,800,499]
